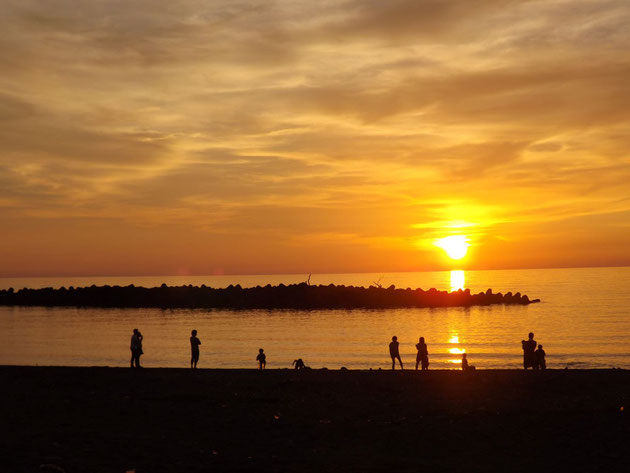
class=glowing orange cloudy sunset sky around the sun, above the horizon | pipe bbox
[0,0,630,276]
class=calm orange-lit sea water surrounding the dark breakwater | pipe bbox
[0,267,630,369]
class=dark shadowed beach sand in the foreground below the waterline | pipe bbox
[0,367,630,473]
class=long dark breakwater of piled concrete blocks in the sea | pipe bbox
[0,283,540,309]
